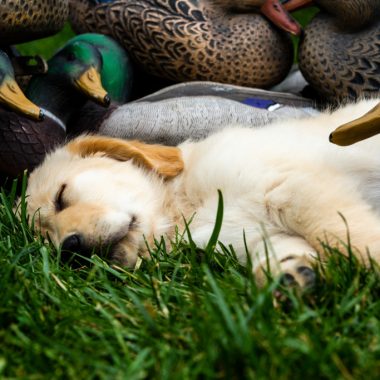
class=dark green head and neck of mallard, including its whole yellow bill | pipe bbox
[27,41,110,125]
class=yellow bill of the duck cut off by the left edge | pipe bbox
[0,79,44,120]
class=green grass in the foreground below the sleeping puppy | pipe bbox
[0,183,380,380]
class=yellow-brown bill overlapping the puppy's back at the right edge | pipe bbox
[330,103,380,146]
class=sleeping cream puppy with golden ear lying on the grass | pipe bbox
[27,100,380,286]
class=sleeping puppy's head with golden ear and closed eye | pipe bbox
[26,136,183,266]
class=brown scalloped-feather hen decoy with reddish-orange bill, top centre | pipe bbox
[70,0,306,87]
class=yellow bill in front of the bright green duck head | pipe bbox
[75,67,110,107]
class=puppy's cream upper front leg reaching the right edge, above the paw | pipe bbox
[264,170,380,264]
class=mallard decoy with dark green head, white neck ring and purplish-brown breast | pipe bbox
[0,36,110,177]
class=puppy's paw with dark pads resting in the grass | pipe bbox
[254,233,318,288]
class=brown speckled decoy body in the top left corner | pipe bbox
[0,0,69,45]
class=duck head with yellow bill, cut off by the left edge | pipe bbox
[0,51,43,120]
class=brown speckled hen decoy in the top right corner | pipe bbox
[287,0,380,102]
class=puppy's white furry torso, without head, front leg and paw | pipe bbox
[169,101,380,260]
